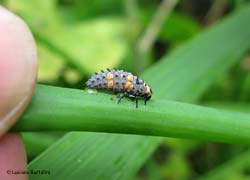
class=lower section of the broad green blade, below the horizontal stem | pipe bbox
[29,133,160,180]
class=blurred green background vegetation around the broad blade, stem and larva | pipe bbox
[0,0,250,180]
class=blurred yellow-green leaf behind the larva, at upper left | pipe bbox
[9,0,128,74]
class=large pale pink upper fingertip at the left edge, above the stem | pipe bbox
[0,7,37,136]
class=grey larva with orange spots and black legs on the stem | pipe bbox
[86,69,152,107]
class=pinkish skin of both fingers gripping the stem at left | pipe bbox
[0,6,37,180]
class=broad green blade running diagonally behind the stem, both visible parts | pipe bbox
[25,5,250,179]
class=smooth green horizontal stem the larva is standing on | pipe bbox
[14,83,250,143]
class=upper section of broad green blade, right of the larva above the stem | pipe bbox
[143,3,250,101]
